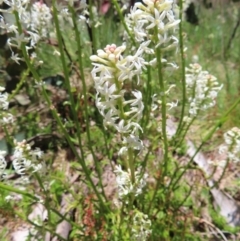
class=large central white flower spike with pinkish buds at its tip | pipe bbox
[90,44,145,154]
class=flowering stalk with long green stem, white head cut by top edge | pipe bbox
[126,0,180,211]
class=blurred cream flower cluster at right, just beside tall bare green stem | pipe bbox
[186,63,222,116]
